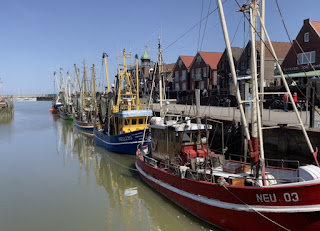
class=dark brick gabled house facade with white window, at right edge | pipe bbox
[282,19,320,85]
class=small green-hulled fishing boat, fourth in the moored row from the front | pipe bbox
[59,69,74,120]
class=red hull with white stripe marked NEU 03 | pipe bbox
[136,158,320,231]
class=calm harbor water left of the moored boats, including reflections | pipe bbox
[0,101,219,231]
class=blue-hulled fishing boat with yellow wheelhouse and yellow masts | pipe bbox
[94,49,152,154]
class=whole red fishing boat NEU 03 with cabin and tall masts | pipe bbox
[136,0,320,231]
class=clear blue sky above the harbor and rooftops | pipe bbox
[0,0,320,95]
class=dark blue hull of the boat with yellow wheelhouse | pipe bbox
[93,128,151,155]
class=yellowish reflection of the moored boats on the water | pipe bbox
[53,114,216,231]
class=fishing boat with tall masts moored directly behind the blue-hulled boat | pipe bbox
[73,64,97,131]
